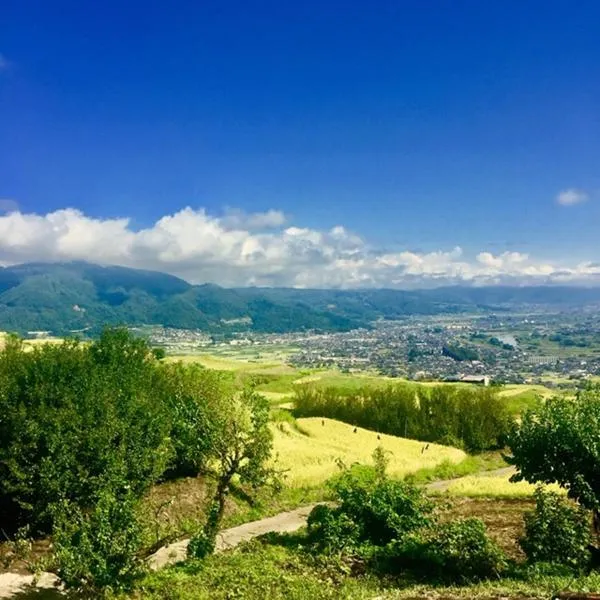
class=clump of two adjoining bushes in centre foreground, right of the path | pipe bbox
[307,451,506,582]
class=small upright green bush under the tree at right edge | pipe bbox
[519,488,592,570]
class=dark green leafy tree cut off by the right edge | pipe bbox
[507,389,600,526]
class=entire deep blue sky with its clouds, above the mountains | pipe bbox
[0,0,600,285]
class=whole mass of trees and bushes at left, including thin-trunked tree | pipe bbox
[0,329,272,596]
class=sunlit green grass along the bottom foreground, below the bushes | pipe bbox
[129,534,600,600]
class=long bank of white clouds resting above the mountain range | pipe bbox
[0,208,600,288]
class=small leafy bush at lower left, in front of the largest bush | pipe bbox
[53,491,144,597]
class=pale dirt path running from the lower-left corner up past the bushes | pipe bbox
[0,467,514,600]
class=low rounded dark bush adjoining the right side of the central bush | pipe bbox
[384,518,506,583]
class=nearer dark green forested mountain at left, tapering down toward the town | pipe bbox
[0,262,366,335]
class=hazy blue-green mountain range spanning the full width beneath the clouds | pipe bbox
[0,262,600,334]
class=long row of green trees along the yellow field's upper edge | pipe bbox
[295,384,510,452]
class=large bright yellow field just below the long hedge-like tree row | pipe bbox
[272,418,466,487]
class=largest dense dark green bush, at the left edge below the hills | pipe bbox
[0,330,171,531]
